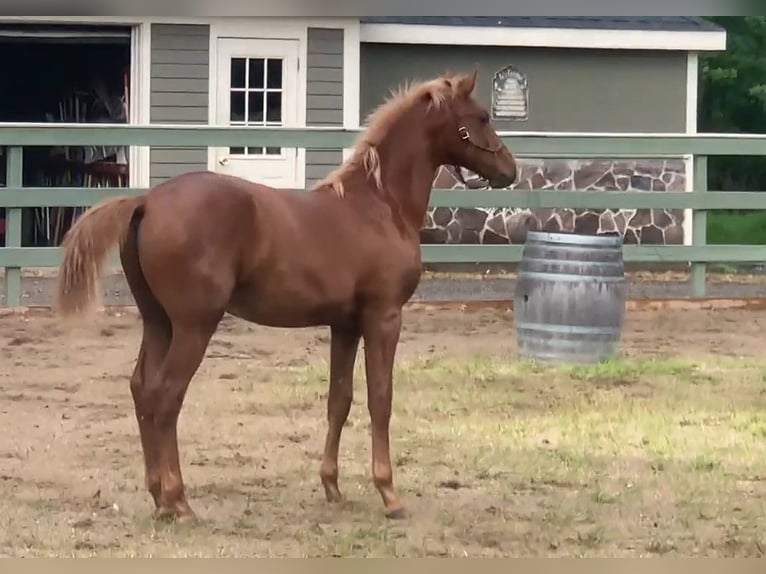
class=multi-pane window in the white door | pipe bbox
[229,58,284,155]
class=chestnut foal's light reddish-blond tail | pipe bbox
[55,196,145,317]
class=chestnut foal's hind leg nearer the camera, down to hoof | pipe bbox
[149,313,223,521]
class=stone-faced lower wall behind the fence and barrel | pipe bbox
[421,159,686,244]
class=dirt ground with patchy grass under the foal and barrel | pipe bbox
[0,310,766,557]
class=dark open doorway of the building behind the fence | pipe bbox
[0,25,131,246]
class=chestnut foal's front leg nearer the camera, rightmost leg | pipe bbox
[363,306,406,518]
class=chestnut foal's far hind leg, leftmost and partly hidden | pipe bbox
[130,318,171,506]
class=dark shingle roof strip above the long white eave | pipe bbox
[361,16,723,32]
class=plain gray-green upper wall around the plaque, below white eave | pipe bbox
[360,44,686,132]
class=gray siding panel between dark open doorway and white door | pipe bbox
[150,24,210,185]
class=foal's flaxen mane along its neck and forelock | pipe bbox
[313,72,468,197]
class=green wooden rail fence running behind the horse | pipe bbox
[0,124,766,306]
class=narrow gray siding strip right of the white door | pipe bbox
[306,28,343,188]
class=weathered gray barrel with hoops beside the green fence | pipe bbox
[513,231,626,363]
